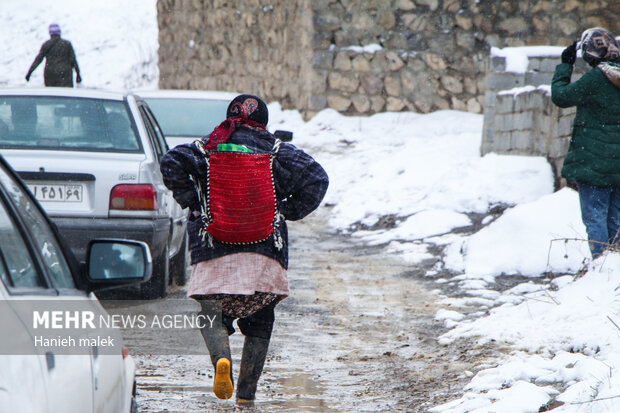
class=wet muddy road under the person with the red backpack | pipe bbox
[118,207,500,413]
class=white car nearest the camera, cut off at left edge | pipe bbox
[0,156,152,413]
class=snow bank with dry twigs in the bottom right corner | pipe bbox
[431,253,620,413]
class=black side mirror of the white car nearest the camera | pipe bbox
[85,239,153,291]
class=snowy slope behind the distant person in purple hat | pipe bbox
[0,0,159,90]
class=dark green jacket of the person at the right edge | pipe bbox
[551,59,620,186]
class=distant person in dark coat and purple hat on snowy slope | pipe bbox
[26,23,82,87]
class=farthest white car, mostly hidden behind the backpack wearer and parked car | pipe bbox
[135,89,238,148]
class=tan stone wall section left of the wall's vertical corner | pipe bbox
[157,0,312,108]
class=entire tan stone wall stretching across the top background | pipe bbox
[158,0,620,117]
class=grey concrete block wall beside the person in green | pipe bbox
[480,54,590,188]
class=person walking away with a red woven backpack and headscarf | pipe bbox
[161,94,329,401]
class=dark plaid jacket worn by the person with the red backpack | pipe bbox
[160,127,329,268]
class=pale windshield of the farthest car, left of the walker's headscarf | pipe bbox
[144,98,230,137]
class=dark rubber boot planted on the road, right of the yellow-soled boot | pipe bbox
[237,336,269,402]
